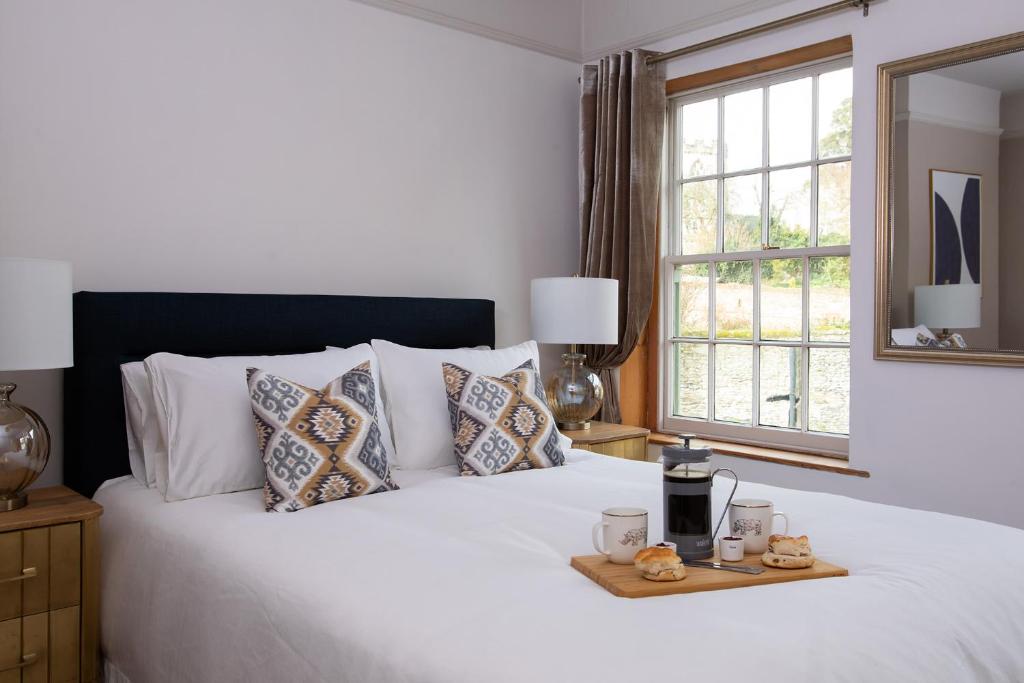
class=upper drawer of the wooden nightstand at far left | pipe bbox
[0,522,82,626]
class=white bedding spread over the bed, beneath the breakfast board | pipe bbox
[96,452,1024,683]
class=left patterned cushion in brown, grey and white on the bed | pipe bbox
[248,362,398,512]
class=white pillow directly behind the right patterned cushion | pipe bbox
[371,339,571,470]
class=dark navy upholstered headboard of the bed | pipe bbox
[63,292,495,496]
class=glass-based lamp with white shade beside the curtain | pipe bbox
[529,278,618,429]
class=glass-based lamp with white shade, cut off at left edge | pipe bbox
[0,257,73,513]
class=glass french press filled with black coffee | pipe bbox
[662,434,739,562]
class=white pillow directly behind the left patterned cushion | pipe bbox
[145,344,394,501]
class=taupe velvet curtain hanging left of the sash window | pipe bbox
[580,50,666,422]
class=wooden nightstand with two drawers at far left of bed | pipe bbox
[0,486,103,683]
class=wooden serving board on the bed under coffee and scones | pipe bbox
[569,555,850,598]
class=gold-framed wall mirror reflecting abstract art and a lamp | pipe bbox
[874,33,1024,366]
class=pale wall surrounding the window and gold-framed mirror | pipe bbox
[638,0,1024,526]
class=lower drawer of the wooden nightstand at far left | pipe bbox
[0,606,80,683]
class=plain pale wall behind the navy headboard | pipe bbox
[0,0,579,491]
